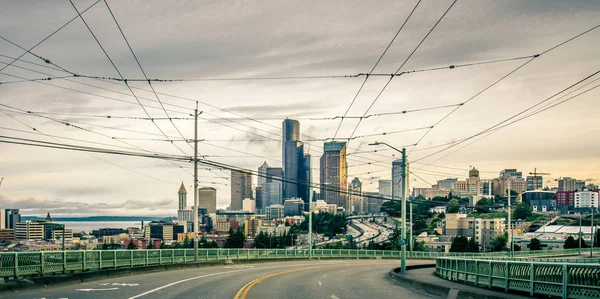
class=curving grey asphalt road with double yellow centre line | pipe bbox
[7,260,432,299]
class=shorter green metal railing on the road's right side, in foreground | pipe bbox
[436,250,600,298]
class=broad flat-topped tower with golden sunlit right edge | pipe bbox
[320,141,348,208]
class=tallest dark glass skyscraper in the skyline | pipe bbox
[282,119,310,202]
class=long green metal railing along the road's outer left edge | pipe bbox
[0,249,588,279]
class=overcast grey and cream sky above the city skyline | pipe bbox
[0,0,600,216]
